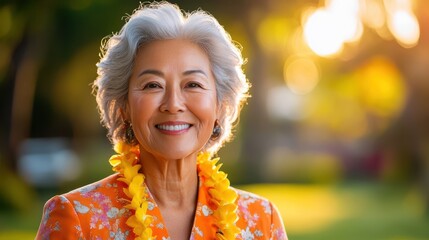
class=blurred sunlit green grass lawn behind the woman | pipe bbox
[0,183,429,240]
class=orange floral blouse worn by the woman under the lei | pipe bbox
[36,174,287,240]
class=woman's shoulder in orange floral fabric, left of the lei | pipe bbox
[37,174,130,239]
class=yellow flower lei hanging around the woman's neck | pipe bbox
[109,142,240,240]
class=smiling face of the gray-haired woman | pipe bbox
[127,39,217,160]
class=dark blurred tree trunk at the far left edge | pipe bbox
[1,0,51,168]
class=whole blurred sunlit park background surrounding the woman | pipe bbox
[0,0,429,240]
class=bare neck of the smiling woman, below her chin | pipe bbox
[140,151,198,211]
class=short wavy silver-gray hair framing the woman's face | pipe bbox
[93,2,250,152]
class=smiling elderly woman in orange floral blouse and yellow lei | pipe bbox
[36,2,287,240]
